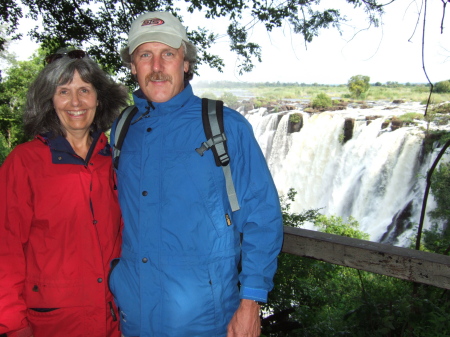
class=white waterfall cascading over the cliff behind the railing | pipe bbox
[241,103,444,246]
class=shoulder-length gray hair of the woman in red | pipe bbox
[23,55,129,137]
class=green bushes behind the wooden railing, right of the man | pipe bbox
[262,189,450,337]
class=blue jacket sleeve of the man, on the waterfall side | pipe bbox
[225,111,283,302]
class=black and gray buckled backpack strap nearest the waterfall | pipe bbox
[195,98,240,212]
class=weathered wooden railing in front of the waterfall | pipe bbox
[282,226,450,289]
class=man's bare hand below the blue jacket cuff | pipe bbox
[227,299,261,337]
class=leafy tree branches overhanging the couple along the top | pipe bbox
[0,0,384,82]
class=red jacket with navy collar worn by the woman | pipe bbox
[0,134,122,337]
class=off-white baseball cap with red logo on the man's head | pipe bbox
[128,12,189,55]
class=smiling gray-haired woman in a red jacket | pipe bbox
[0,50,128,337]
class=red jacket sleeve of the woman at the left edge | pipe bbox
[0,150,32,337]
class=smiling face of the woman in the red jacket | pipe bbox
[53,70,98,135]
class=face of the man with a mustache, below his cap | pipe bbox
[131,42,189,103]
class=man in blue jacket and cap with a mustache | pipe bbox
[109,12,283,337]
